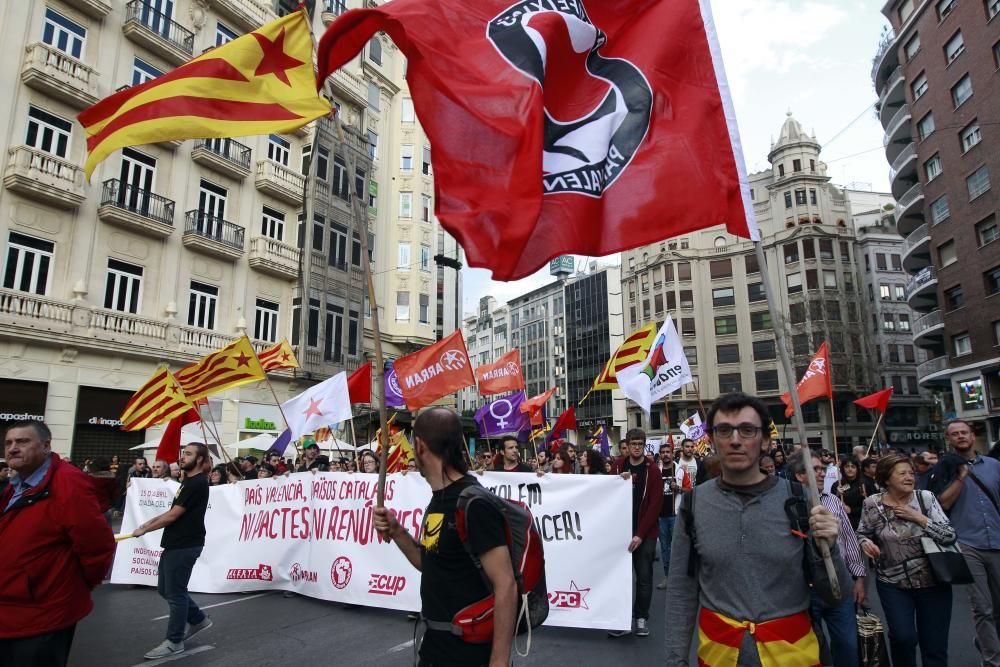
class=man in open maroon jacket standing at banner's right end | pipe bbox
[608,428,663,637]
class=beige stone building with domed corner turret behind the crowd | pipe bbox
[622,114,874,451]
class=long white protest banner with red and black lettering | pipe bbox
[111,472,632,630]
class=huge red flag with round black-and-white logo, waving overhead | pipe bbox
[318,0,759,280]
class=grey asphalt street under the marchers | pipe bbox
[70,576,978,667]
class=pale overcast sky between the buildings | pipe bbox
[462,0,889,313]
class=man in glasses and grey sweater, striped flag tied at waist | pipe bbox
[666,392,851,667]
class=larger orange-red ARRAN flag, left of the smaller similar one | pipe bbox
[393,331,476,410]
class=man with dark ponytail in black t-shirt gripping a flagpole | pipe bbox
[374,408,518,667]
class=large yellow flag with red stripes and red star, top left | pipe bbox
[77,11,331,180]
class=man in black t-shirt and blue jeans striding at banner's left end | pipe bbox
[132,443,212,660]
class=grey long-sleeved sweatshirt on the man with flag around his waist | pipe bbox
[666,479,850,667]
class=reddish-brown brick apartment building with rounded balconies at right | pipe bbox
[872,0,1000,445]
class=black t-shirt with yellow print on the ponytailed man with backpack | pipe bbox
[420,475,507,667]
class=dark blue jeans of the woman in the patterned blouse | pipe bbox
[875,581,951,667]
